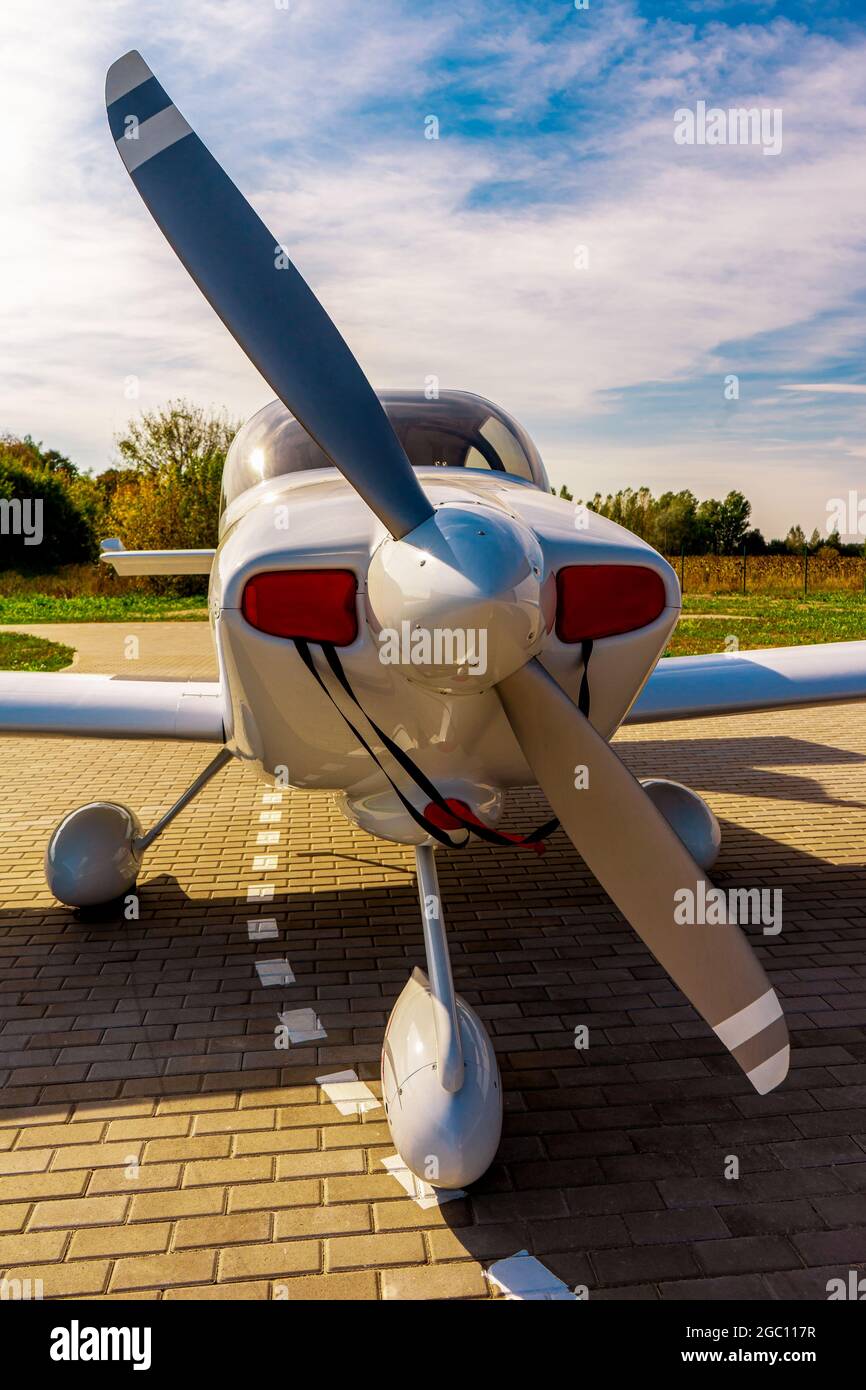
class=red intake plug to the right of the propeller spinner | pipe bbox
[556,564,664,642]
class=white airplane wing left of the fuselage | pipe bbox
[0,671,225,744]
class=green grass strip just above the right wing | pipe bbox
[664,591,866,656]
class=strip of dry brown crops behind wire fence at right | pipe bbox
[666,553,866,595]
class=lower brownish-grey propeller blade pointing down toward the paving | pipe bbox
[496,660,790,1095]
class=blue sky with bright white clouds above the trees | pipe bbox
[0,0,866,539]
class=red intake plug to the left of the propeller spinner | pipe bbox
[240,570,357,646]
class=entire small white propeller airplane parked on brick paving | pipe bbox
[0,51,866,1187]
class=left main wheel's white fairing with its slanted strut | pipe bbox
[44,748,232,908]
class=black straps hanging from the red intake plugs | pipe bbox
[295,638,592,853]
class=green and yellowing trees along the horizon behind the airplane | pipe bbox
[0,400,863,574]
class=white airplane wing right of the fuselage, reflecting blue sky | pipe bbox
[623,642,866,724]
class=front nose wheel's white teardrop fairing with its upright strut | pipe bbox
[382,842,502,1188]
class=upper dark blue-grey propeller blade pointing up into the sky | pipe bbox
[106,51,432,539]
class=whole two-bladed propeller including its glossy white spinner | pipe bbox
[106,51,790,1094]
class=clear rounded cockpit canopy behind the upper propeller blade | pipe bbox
[222,391,549,507]
